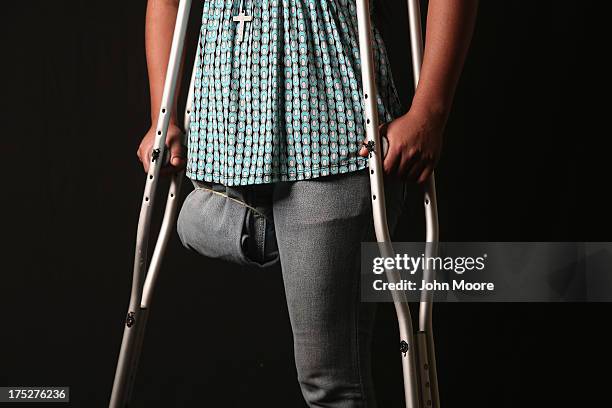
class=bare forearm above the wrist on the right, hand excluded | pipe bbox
[412,0,478,117]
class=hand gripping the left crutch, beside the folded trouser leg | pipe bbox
[136,124,187,176]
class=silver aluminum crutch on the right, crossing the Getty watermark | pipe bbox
[356,0,440,408]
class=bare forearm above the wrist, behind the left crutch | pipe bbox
[145,0,183,126]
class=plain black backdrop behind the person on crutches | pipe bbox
[0,0,612,407]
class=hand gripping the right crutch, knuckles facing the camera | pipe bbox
[359,110,446,184]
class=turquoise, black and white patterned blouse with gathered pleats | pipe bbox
[186,0,402,186]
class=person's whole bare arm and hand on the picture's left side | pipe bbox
[137,0,185,175]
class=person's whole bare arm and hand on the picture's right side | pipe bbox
[360,0,478,183]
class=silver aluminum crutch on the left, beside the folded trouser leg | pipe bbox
[109,0,193,408]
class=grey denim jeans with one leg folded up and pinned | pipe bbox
[177,168,408,408]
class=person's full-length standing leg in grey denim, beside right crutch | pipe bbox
[273,169,404,408]
